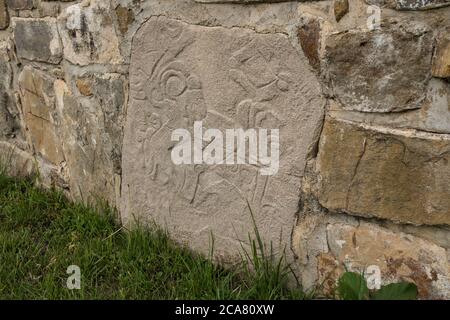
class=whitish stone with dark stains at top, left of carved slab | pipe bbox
[58,0,123,66]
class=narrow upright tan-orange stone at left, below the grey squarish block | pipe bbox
[19,67,64,165]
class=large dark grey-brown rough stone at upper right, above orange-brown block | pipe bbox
[326,26,433,112]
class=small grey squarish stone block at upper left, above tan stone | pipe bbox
[12,18,62,64]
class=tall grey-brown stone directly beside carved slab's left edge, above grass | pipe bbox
[54,74,126,205]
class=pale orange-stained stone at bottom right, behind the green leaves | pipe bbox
[319,222,450,299]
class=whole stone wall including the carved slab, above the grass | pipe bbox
[0,0,450,299]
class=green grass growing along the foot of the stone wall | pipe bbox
[0,174,304,299]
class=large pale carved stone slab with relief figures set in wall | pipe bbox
[121,17,324,259]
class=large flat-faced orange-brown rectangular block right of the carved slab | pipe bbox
[317,119,450,225]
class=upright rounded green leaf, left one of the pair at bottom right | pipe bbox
[337,272,369,300]
